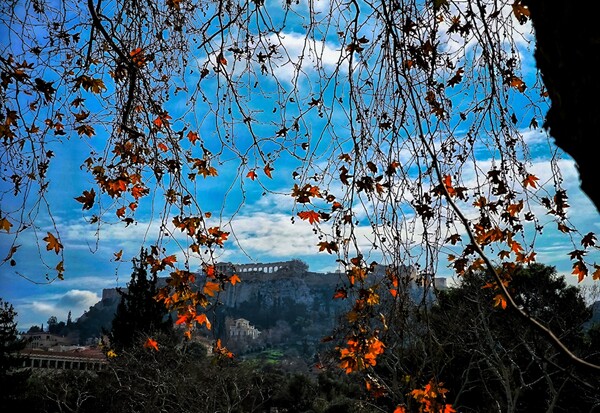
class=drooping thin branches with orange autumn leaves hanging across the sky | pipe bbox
[0,0,600,412]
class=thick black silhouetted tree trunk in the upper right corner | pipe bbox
[523,0,600,211]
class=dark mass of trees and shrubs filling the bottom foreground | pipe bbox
[12,265,600,413]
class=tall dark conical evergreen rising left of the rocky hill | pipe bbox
[109,248,173,351]
